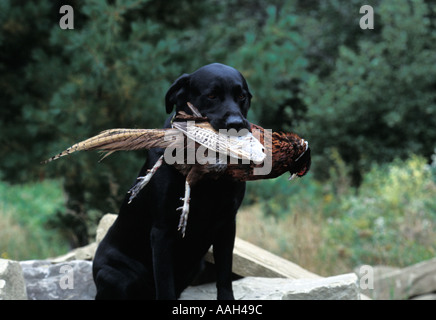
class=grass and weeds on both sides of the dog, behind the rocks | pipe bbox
[0,156,436,276]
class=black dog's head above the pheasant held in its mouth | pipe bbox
[165,63,251,131]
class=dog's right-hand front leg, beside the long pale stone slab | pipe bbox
[213,219,236,300]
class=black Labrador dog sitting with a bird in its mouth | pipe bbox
[93,63,251,299]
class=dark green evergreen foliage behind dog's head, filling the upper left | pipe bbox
[0,0,305,245]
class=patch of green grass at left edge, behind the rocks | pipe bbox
[0,180,69,260]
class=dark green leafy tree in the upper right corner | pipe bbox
[298,1,436,181]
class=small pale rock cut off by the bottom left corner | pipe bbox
[0,259,27,300]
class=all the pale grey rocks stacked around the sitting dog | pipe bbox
[0,215,436,300]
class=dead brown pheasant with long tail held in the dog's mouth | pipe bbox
[44,103,311,236]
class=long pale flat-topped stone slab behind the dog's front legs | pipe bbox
[180,273,360,300]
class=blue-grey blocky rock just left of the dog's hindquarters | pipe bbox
[20,260,96,300]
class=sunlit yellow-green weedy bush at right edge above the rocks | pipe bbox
[323,156,436,266]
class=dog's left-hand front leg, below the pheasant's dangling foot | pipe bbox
[151,226,177,300]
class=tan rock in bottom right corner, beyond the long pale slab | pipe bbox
[358,258,436,300]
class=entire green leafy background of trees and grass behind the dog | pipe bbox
[0,0,436,274]
